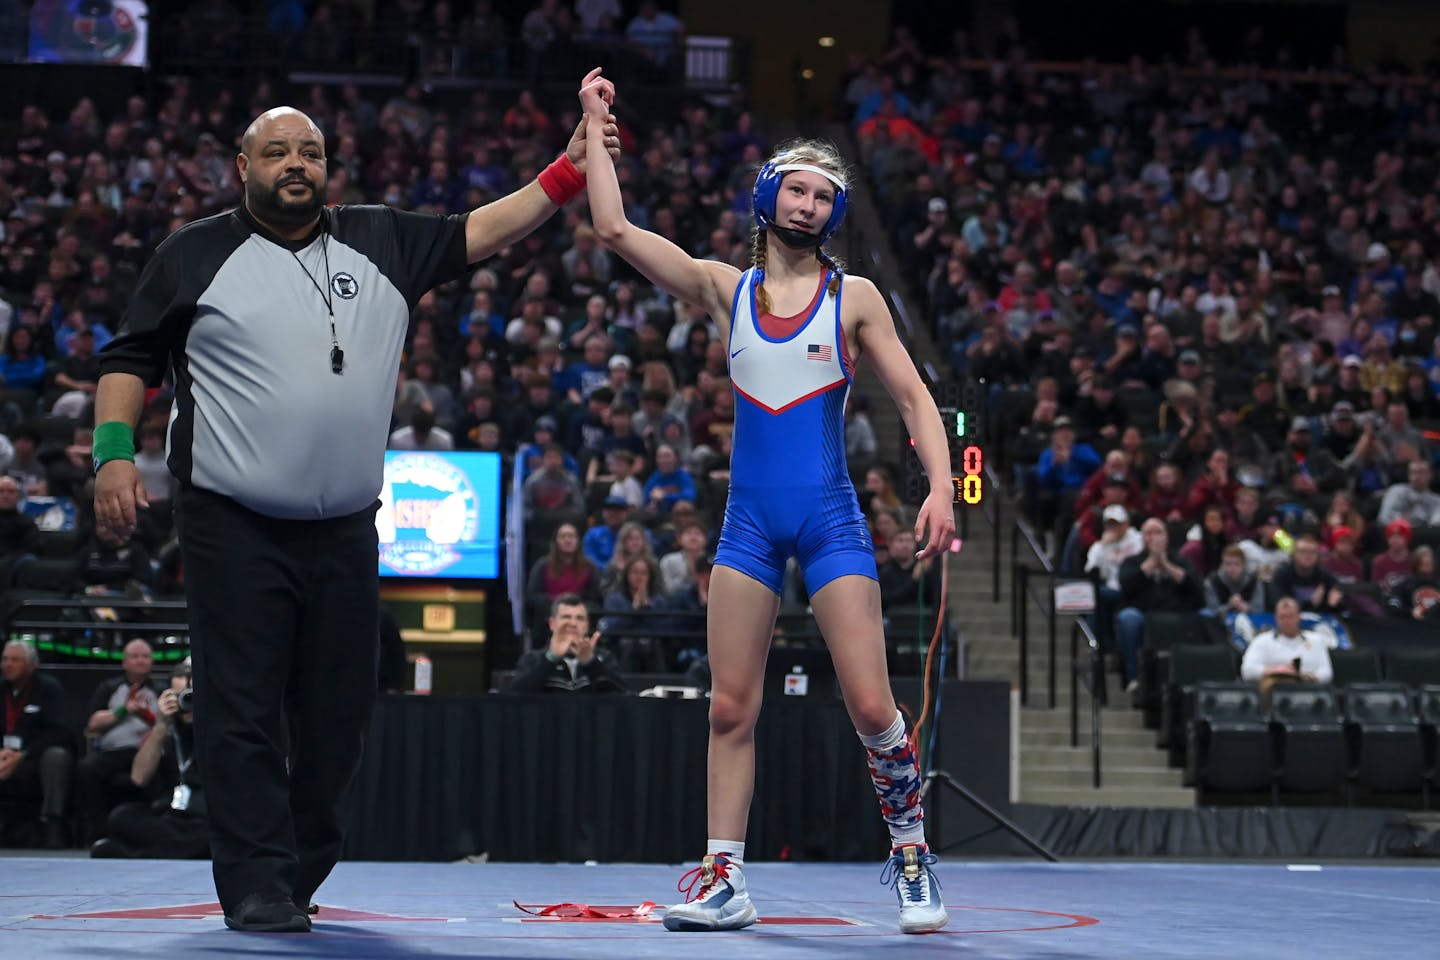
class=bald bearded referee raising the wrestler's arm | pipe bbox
[95,73,619,931]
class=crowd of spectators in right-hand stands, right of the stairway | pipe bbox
[842,23,1440,690]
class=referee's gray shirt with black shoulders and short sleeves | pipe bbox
[101,206,467,520]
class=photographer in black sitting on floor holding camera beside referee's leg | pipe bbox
[91,658,210,859]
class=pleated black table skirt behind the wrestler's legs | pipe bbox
[346,695,888,862]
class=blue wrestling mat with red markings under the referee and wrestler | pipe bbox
[0,858,1440,960]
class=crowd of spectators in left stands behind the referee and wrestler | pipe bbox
[0,13,937,690]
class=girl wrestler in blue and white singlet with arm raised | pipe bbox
[580,69,955,933]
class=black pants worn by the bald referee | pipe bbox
[180,486,379,913]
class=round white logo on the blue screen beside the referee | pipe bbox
[374,453,480,576]
